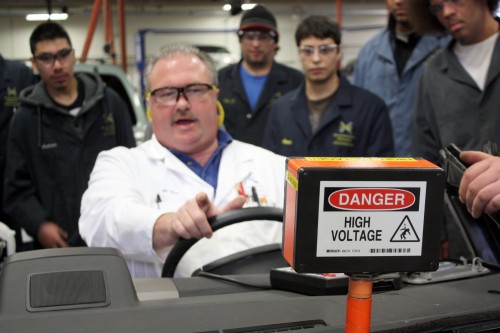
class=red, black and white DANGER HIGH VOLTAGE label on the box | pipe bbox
[317,181,426,257]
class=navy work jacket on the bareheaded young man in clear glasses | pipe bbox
[263,76,394,157]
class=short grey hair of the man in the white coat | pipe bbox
[145,44,219,90]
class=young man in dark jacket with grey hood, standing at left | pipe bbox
[4,21,135,248]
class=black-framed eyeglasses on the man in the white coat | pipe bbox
[148,83,217,106]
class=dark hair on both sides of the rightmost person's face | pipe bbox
[407,0,498,34]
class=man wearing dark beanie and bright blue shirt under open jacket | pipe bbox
[219,5,303,145]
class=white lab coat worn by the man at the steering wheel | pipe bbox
[79,136,285,277]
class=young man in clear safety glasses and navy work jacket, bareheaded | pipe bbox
[263,16,394,157]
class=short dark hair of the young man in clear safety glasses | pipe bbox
[295,15,341,46]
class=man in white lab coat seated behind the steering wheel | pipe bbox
[79,45,285,277]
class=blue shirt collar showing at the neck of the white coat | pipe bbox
[169,129,233,190]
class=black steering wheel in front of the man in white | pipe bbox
[161,207,283,277]
